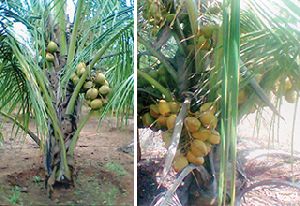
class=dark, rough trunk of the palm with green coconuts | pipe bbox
[44,54,79,197]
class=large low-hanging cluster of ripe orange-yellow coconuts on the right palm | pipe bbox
[142,100,221,172]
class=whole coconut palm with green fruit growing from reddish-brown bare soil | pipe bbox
[0,0,133,195]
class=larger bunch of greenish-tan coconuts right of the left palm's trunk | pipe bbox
[71,62,111,110]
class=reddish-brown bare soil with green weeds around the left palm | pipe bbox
[0,118,134,206]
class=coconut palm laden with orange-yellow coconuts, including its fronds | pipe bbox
[138,0,299,205]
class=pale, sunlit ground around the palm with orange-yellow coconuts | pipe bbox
[138,103,300,206]
